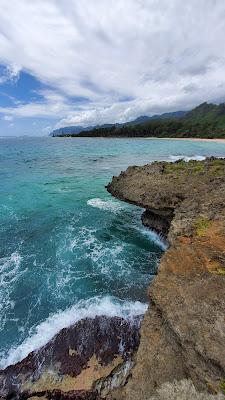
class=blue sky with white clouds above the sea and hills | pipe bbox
[0,0,225,136]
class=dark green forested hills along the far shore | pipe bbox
[55,103,225,138]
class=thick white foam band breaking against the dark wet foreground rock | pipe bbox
[0,296,147,368]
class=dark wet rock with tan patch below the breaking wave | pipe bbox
[0,317,140,400]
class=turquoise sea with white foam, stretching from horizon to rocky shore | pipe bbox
[0,138,225,367]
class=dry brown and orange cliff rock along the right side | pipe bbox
[107,158,225,400]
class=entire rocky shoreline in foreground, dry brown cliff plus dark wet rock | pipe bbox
[0,158,225,400]
